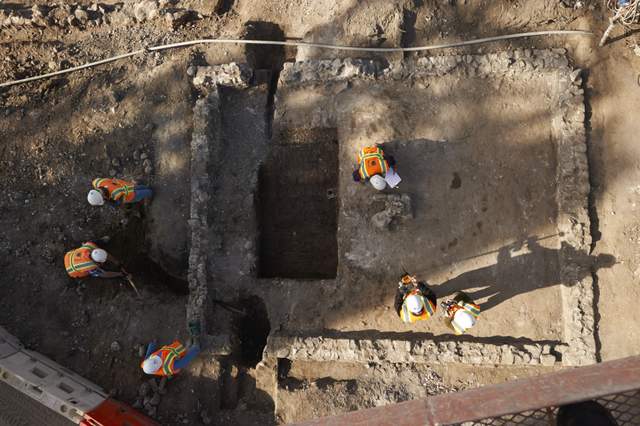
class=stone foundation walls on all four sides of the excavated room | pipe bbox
[188,49,596,365]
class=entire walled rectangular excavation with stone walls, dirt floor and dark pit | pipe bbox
[182,51,594,426]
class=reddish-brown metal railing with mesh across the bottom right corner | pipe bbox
[302,356,640,426]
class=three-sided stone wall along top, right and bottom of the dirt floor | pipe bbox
[270,49,596,365]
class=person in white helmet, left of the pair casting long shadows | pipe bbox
[394,274,437,323]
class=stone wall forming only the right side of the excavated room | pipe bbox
[553,70,597,365]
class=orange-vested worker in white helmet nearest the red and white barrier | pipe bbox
[140,340,200,376]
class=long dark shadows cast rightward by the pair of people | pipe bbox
[434,236,616,311]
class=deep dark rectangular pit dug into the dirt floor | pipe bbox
[258,129,338,279]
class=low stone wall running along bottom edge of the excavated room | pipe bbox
[264,335,565,366]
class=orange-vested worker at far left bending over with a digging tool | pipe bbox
[64,241,129,279]
